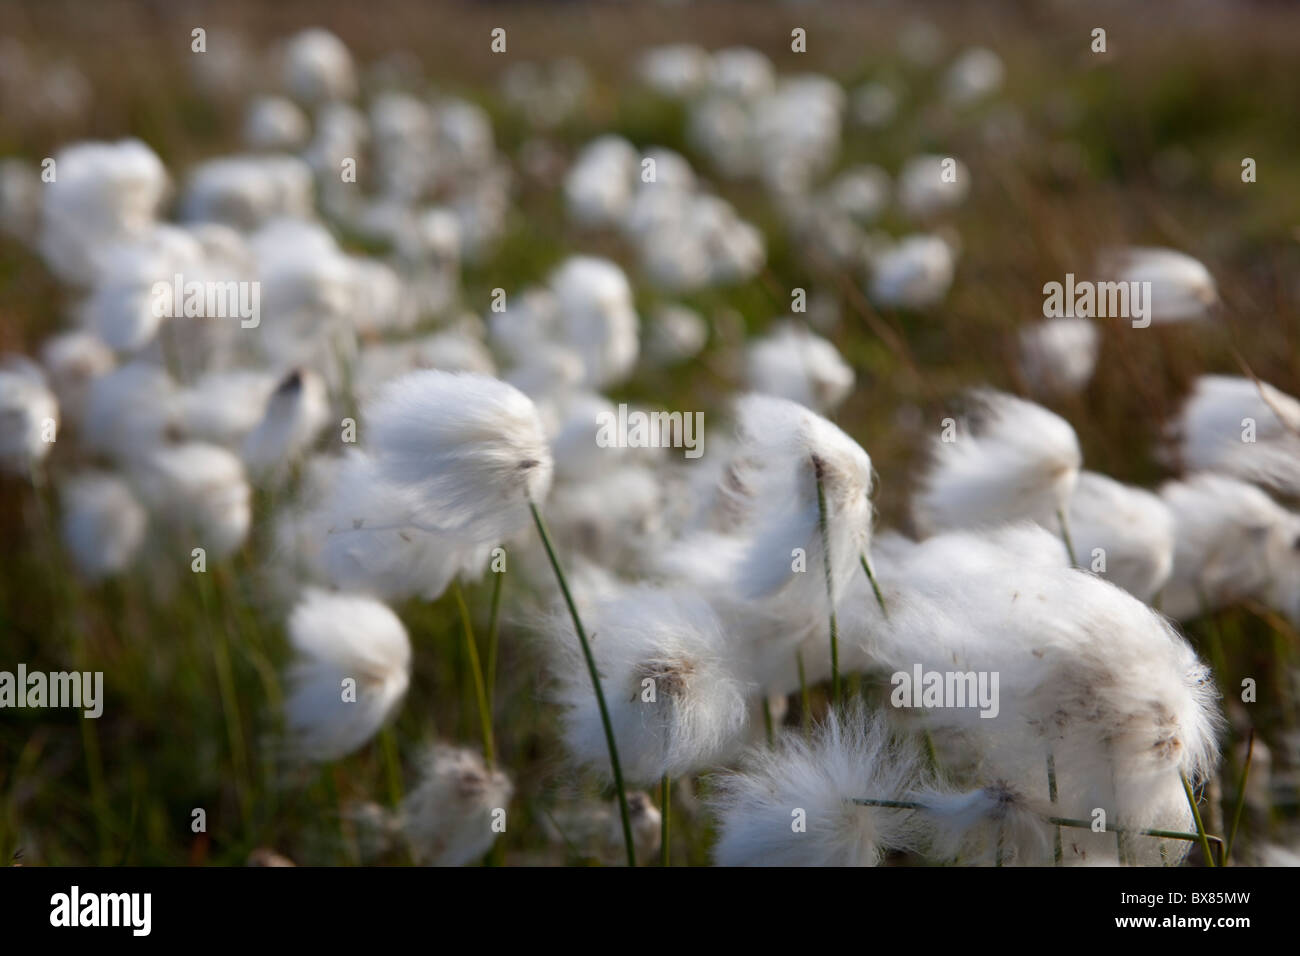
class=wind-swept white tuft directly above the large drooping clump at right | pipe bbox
[913,389,1083,533]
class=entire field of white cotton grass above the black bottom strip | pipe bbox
[0,3,1300,866]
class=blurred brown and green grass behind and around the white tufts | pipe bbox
[0,0,1300,865]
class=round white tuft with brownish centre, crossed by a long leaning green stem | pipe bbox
[551,588,749,783]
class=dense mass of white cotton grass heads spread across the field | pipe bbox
[0,16,1300,865]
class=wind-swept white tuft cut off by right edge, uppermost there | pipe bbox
[1169,375,1300,496]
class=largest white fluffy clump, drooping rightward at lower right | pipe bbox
[841,528,1221,862]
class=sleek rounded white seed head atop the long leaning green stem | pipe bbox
[364,369,553,544]
